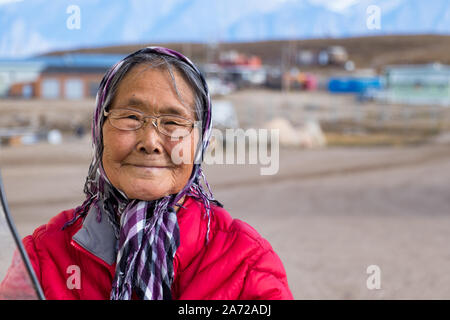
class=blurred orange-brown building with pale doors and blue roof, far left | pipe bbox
[0,54,123,99]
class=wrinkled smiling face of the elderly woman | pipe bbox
[102,65,199,201]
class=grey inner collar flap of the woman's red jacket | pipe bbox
[72,201,118,266]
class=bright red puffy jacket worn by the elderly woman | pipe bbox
[0,197,292,300]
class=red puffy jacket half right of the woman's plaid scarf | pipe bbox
[175,196,292,300]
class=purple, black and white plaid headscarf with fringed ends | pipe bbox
[65,47,220,300]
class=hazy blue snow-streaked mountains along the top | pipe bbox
[0,0,450,57]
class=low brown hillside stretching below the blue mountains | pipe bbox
[44,35,450,69]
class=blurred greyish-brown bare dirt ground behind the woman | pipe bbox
[0,139,450,299]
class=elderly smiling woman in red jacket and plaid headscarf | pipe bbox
[3,47,292,299]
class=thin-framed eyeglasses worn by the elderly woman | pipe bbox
[103,109,195,139]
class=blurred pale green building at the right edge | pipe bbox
[384,63,450,106]
